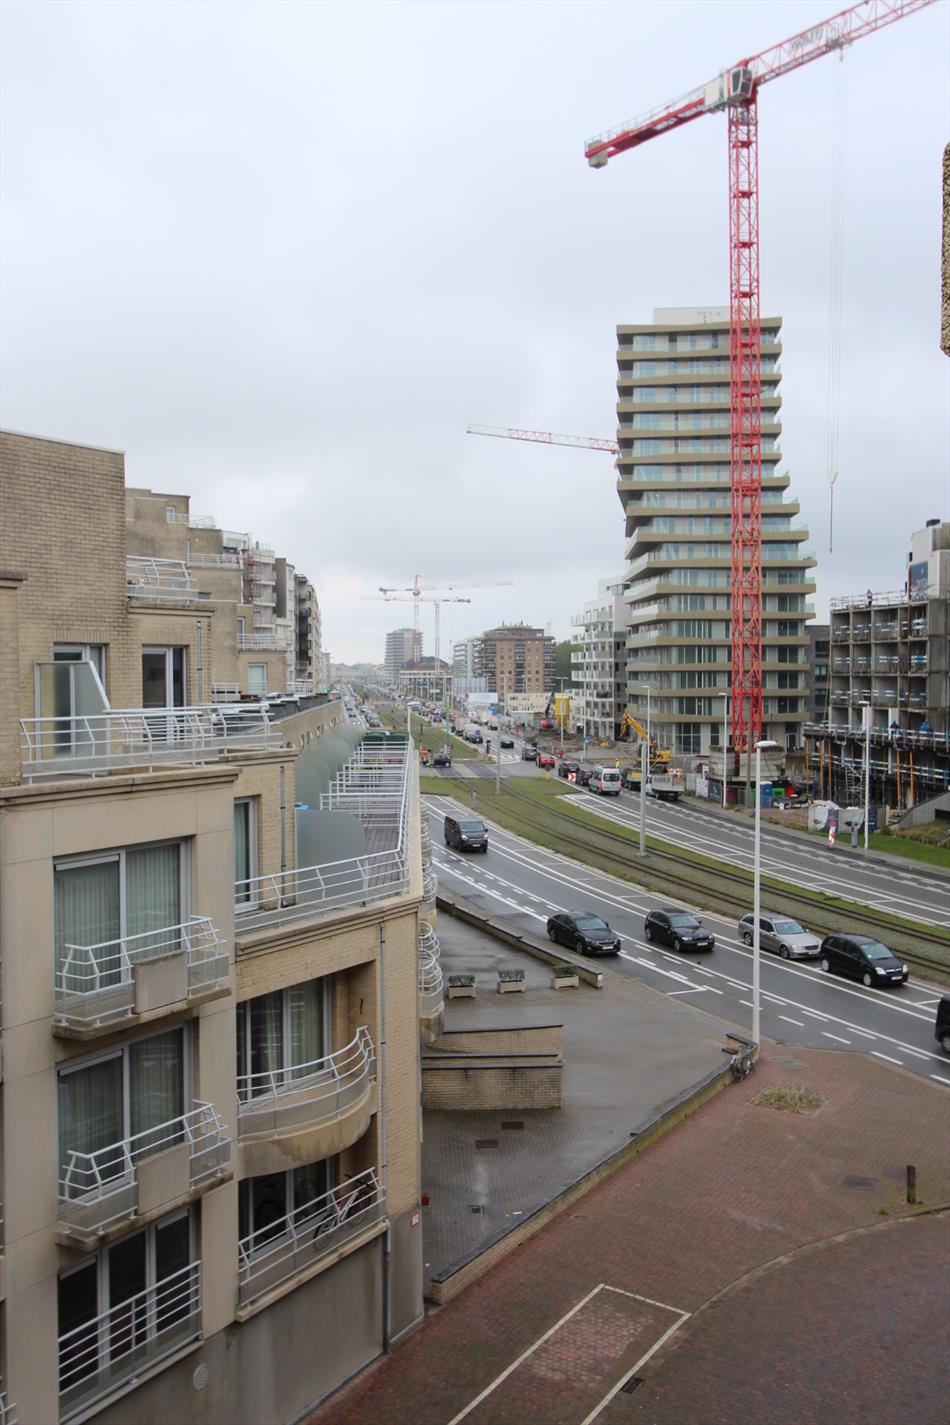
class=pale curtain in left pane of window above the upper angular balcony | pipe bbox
[53,858,121,992]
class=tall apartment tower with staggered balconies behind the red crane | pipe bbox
[617,308,816,754]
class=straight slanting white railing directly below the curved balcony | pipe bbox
[238,1167,386,1305]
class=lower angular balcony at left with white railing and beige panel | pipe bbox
[57,1103,231,1247]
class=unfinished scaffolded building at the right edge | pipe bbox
[808,519,950,808]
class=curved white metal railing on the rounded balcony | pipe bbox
[238,1025,376,1140]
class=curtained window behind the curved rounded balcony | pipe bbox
[238,979,330,1103]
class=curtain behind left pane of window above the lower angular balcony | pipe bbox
[58,1055,125,1197]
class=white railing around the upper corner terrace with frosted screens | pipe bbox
[235,740,413,933]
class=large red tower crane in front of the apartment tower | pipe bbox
[584,0,934,751]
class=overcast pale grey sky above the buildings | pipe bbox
[0,0,950,661]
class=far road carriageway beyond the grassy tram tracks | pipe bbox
[441,731,950,931]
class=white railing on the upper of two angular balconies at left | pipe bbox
[54,915,228,1031]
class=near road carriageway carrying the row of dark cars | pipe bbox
[426,797,950,1086]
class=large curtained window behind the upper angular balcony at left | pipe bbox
[53,841,188,990]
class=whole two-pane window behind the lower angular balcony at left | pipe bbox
[57,1026,191,1198]
